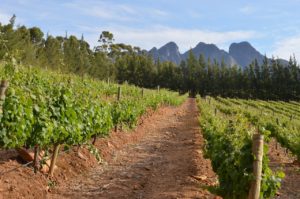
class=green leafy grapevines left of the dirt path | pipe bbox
[0,61,185,175]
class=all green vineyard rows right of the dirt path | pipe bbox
[198,97,300,198]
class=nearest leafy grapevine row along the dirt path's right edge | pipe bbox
[198,98,284,198]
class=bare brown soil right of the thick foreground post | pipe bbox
[268,139,300,199]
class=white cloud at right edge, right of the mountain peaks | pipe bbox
[272,35,300,60]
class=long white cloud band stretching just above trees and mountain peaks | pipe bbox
[80,26,261,52]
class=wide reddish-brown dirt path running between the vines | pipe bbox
[48,99,216,199]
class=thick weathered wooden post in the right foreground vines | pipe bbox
[248,133,264,199]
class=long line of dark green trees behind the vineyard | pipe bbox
[0,15,300,100]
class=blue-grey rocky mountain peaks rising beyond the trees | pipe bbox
[148,41,288,67]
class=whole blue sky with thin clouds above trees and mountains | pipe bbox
[0,0,300,60]
